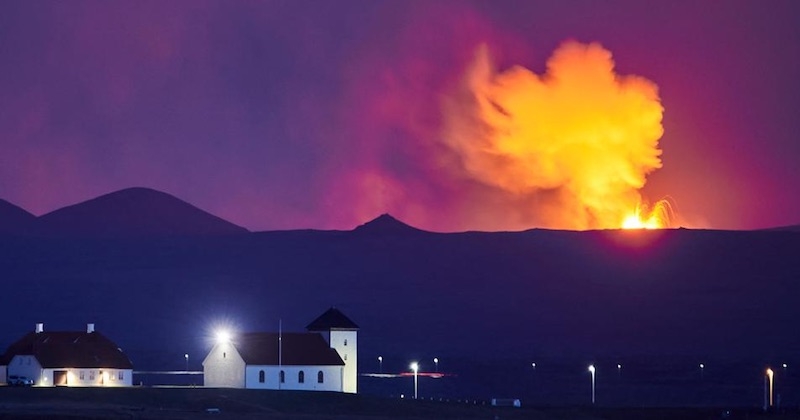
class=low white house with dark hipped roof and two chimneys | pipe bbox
[0,324,133,387]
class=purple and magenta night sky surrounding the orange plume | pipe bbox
[0,0,800,230]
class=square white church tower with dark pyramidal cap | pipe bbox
[306,307,358,394]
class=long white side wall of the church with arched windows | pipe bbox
[245,365,344,392]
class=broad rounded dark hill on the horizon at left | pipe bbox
[36,187,247,237]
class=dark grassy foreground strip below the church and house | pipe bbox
[0,388,800,420]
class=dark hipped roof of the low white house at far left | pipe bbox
[0,331,133,369]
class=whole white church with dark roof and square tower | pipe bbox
[203,308,358,393]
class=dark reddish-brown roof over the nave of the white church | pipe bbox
[234,333,344,366]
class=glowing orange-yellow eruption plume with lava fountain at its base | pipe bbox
[442,41,672,230]
